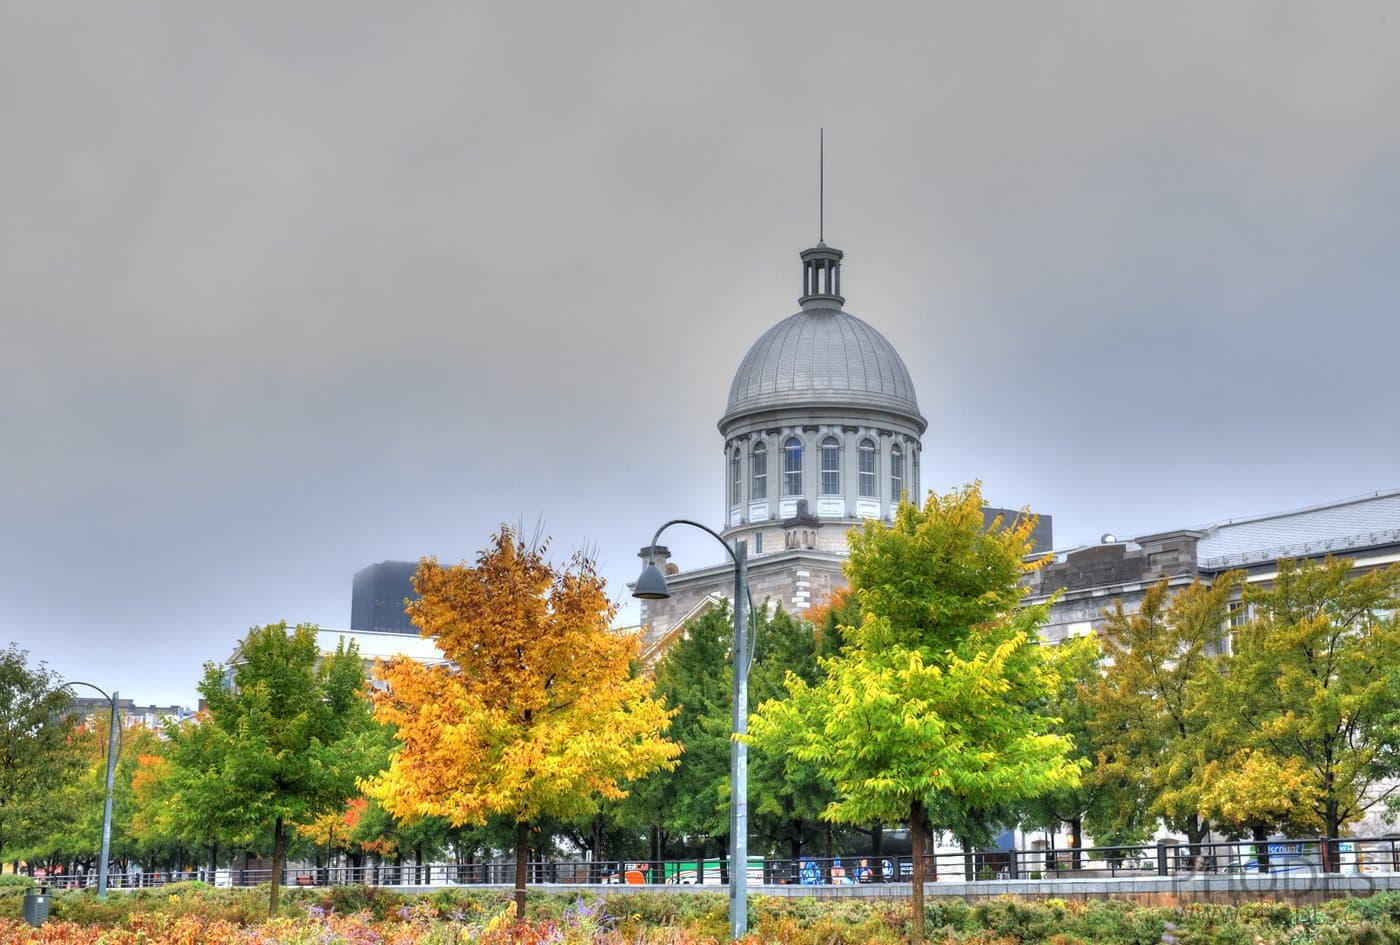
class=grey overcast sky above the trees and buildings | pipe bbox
[0,0,1400,704]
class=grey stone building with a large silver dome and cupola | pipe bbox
[640,242,928,652]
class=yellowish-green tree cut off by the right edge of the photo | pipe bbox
[1228,557,1400,839]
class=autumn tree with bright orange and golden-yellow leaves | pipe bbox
[364,526,680,920]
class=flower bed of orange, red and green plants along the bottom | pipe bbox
[0,883,1400,945]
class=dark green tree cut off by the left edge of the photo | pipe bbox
[0,644,85,858]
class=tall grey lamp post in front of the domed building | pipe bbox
[631,518,753,941]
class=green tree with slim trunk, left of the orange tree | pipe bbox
[169,623,377,914]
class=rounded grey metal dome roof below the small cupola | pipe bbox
[721,308,925,431]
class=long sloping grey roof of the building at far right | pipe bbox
[1196,490,1400,570]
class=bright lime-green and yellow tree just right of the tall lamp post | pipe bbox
[752,484,1079,939]
